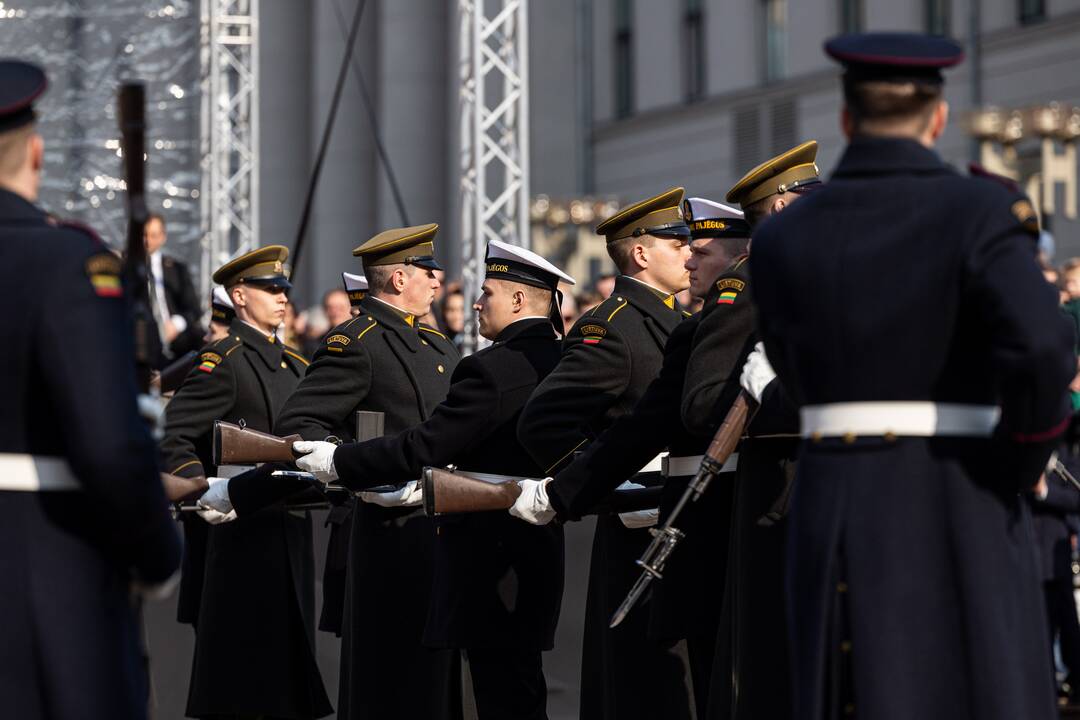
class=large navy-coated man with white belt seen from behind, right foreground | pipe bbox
[751,33,1076,720]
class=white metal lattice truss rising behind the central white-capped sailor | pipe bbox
[458,0,529,353]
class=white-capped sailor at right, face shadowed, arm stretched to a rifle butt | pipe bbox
[512,198,752,717]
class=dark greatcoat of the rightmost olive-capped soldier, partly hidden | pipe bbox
[683,258,799,720]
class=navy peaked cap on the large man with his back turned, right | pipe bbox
[825,32,963,85]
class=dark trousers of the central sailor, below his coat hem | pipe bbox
[465,648,548,720]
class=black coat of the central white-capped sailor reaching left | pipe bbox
[334,318,563,717]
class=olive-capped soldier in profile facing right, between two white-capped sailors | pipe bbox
[518,188,690,720]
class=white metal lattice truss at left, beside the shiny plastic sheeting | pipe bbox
[200,0,259,297]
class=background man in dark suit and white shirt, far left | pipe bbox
[143,213,203,359]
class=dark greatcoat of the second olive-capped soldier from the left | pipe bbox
[278,296,460,720]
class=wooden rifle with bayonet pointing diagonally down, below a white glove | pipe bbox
[610,391,754,627]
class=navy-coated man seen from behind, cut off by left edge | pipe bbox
[0,60,180,720]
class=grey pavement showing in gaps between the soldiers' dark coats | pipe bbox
[145,514,593,720]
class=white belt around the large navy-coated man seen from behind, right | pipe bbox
[800,402,1001,440]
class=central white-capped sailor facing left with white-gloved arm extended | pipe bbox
[287,241,573,720]
